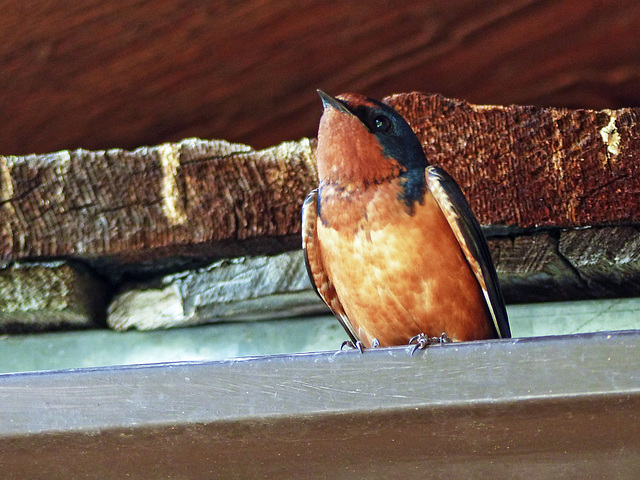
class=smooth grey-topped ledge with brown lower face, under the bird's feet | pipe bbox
[0,332,640,479]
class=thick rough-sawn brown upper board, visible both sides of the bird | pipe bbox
[0,97,640,262]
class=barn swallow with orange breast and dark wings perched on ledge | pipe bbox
[302,91,511,348]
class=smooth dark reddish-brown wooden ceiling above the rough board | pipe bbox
[0,0,640,154]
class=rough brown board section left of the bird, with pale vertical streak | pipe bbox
[0,139,315,262]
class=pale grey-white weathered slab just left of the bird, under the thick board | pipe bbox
[107,250,329,330]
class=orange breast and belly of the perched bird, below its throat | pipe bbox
[317,180,493,346]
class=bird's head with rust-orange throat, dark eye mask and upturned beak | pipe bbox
[316,90,429,186]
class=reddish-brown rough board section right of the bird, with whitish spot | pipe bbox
[388,93,640,227]
